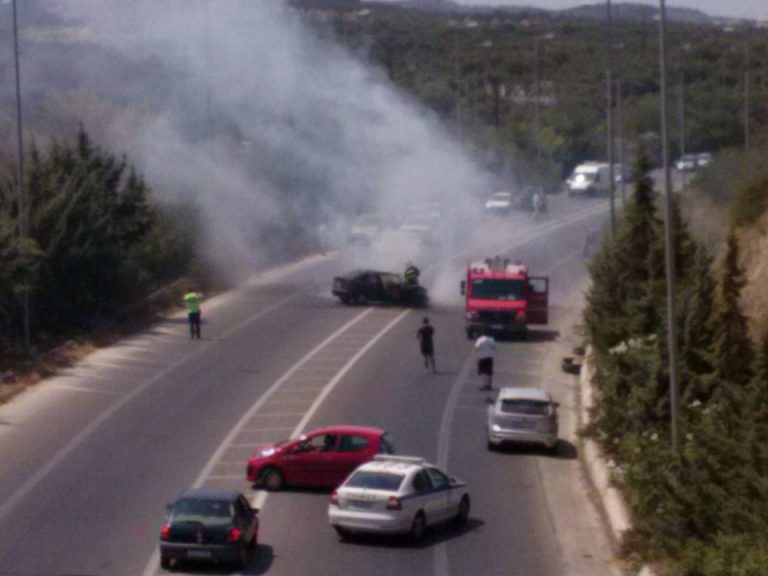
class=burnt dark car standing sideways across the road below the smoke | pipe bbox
[331,270,429,307]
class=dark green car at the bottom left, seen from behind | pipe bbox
[160,490,259,570]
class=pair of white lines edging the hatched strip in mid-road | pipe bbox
[142,308,411,576]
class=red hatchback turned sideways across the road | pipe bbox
[247,426,394,490]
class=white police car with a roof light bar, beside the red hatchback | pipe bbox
[328,455,470,540]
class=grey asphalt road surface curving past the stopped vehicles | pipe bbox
[0,192,606,576]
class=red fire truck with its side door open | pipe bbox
[461,257,549,340]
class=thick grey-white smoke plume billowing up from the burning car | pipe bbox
[28,0,510,302]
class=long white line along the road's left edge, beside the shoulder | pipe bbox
[0,293,296,523]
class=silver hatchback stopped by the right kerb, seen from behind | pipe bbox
[488,388,558,450]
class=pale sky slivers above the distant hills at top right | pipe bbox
[414,0,768,20]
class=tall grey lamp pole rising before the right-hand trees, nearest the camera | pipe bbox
[659,0,680,454]
